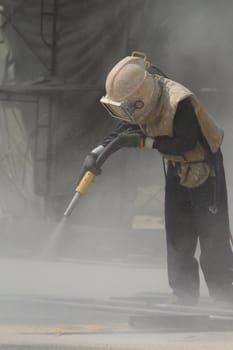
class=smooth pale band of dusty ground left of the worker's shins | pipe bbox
[0,259,169,299]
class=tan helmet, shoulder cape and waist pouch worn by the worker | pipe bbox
[101,52,223,188]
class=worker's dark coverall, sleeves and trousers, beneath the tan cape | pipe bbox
[103,98,233,303]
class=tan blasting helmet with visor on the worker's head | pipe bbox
[100,52,159,124]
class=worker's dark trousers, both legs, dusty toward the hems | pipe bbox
[165,153,233,301]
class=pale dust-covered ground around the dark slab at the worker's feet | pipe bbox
[0,259,233,350]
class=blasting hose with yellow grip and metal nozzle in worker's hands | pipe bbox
[64,134,133,217]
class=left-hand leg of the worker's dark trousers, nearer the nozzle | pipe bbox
[165,166,200,303]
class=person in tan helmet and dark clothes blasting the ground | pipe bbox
[80,52,233,305]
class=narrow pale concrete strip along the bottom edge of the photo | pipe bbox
[0,333,233,350]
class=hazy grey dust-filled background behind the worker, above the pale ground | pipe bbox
[0,0,233,260]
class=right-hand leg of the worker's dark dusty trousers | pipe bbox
[191,152,233,302]
